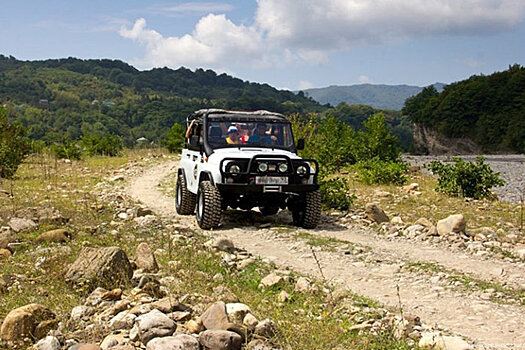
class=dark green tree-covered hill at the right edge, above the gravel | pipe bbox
[402,64,525,153]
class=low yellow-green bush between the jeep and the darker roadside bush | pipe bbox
[355,157,408,185]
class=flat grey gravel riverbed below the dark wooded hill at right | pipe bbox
[403,154,525,203]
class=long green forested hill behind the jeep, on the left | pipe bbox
[0,55,325,145]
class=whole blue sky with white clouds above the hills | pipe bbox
[0,0,525,90]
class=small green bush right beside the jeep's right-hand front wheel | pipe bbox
[319,177,355,210]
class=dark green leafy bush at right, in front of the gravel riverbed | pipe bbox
[428,157,505,199]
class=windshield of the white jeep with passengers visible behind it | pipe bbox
[207,118,295,151]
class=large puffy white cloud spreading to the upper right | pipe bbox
[120,0,525,70]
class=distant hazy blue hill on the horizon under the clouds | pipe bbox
[304,83,444,110]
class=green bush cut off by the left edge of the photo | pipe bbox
[0,107,30,179]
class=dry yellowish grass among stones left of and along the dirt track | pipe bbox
[0,150,420,349]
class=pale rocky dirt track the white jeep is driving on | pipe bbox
[127,161,525,349]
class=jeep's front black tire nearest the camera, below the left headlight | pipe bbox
[196,181,222,230]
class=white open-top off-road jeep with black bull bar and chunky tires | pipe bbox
[175,109,321,230]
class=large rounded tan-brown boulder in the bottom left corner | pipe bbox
[0,304,55,340]
